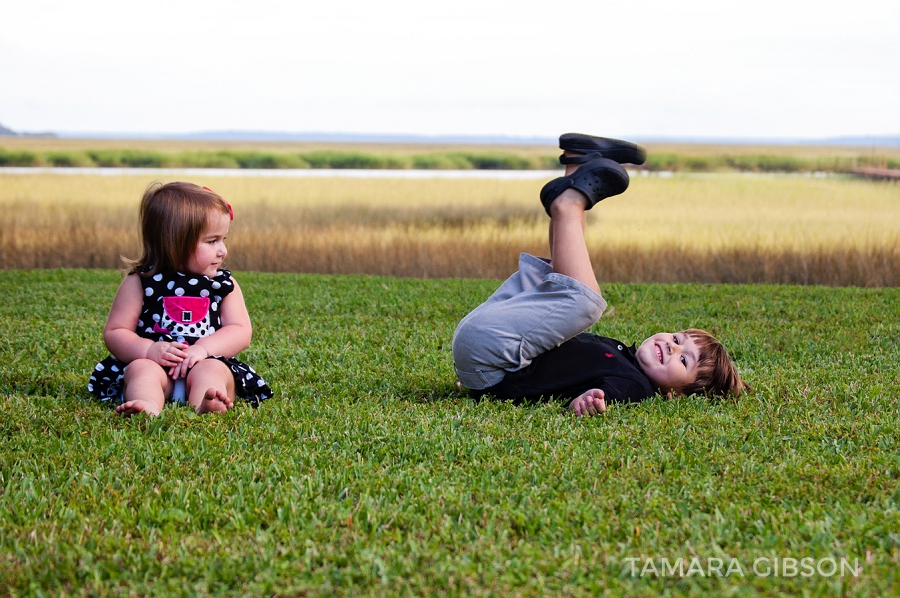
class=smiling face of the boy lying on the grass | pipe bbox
[635,332,700,395]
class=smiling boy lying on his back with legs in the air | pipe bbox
[453,133,747,415]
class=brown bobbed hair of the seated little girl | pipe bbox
[122,181,231,276]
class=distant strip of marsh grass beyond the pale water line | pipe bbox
[0,137,900,172]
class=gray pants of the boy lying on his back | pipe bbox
[453,253,606,390]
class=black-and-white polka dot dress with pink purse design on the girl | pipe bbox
[88,270,272,407]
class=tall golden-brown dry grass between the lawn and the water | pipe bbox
[0,174,900,286]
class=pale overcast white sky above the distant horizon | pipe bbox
[0,0,900,139]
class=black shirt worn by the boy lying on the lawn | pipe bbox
[482,332,656,403]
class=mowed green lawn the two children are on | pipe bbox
[0,270,900,596]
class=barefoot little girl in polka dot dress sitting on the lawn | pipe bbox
[88,183,272,416]
